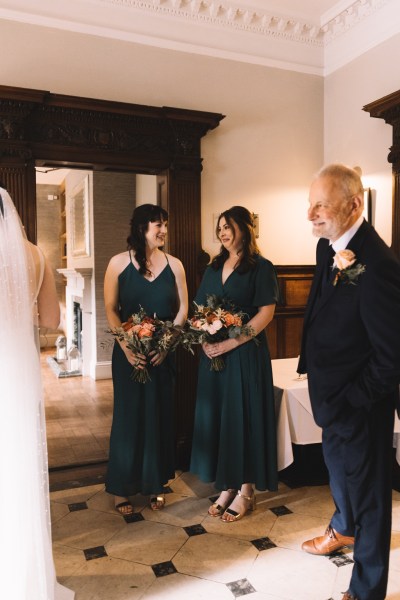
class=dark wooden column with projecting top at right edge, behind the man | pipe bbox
[363,91,400,256]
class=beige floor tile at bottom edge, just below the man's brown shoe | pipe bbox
[247,548,338,600]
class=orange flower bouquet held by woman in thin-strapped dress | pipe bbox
[109,307,182,383]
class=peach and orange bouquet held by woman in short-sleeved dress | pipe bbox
[181,295,258,371]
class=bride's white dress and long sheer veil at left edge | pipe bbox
[0,188,74,600]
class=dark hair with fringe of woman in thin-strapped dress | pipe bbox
[126,204,168,275]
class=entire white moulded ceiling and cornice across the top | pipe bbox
[0,0,400,75]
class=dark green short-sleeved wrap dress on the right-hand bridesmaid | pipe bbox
[190,256,279,490]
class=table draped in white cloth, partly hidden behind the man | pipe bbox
[272,358,400,478]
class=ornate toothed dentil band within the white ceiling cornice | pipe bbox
[101,0,390,46]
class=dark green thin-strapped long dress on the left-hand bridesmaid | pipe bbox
[106,262,177,496]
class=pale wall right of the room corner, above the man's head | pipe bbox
[324,35,400,244]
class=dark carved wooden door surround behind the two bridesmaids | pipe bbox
[0,86,224,468]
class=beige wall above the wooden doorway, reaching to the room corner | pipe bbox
[0,21,323,264]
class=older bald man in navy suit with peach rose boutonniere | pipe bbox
[298,164,400,600]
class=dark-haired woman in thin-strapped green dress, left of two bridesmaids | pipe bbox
[104,204,188,516]
